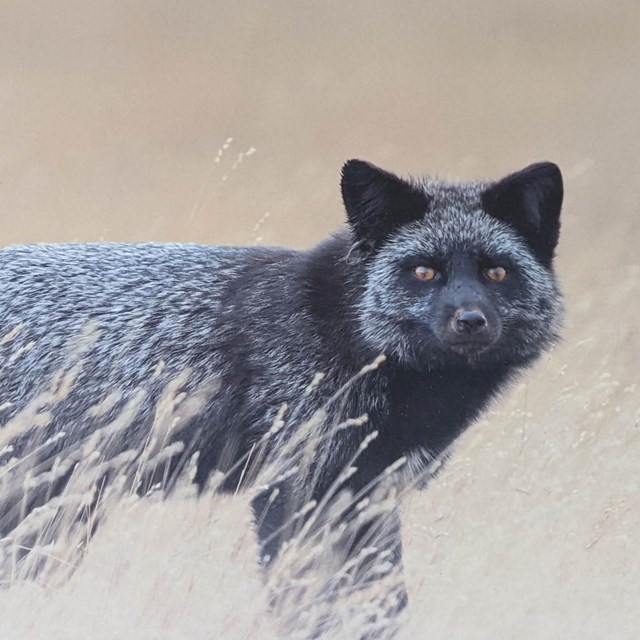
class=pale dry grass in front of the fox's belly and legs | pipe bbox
[0,348,416,639]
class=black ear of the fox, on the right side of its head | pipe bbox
[482,162,563,266]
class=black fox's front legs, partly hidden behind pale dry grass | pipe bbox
[252,483,407,640]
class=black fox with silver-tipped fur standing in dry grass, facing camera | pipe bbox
[0,160,563,636]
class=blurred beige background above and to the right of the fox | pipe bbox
[0,0,640,639]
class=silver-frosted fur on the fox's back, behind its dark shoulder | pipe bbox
[0,244,291,432]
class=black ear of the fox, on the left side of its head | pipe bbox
[341,160,429,250]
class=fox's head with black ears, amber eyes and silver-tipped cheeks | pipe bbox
[342,160,562,368]
